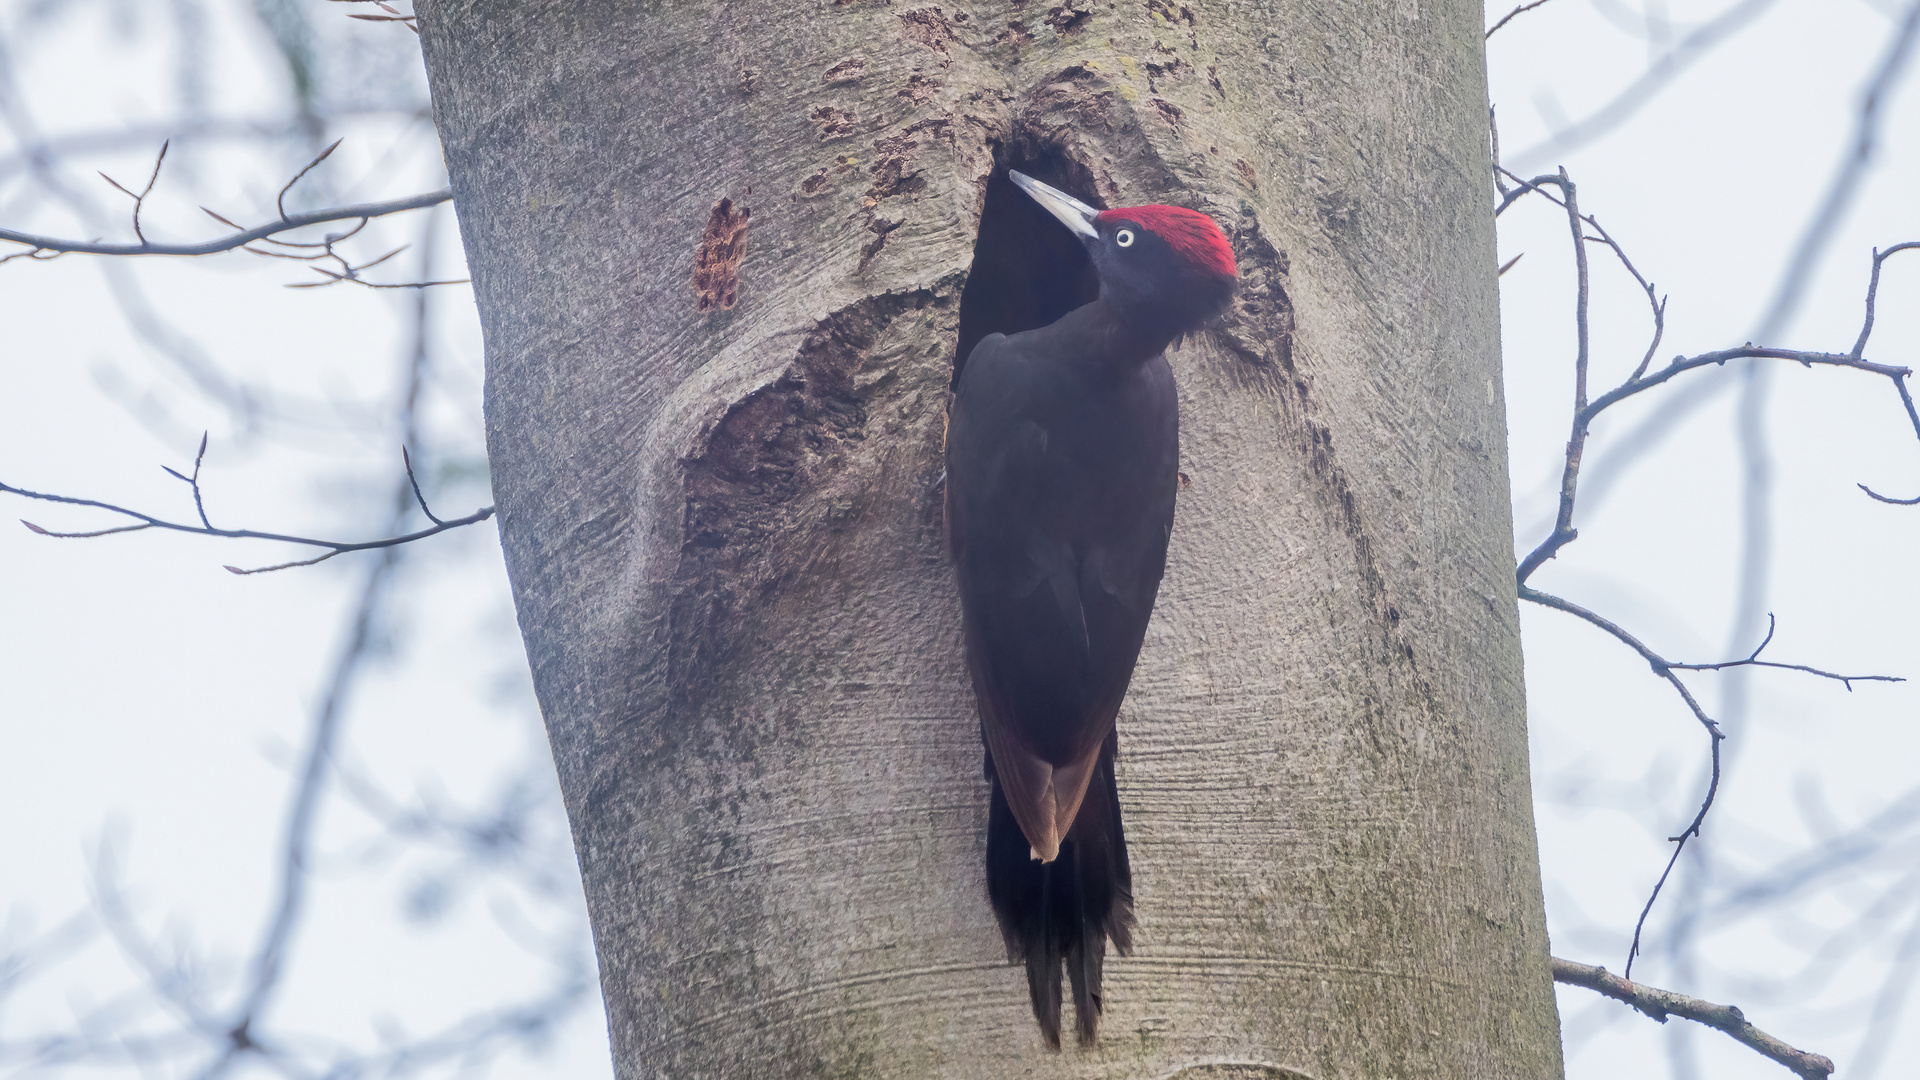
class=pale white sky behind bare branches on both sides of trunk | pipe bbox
[0,0,1920,1080]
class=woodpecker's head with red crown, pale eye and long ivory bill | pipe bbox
[1008,169,1238,338]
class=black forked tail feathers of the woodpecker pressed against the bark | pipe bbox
[987,734,1133,1049]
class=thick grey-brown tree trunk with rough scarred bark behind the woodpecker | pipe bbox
[419,0,1559,1080]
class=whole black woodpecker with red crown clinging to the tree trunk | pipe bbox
[947,173,1236,1049]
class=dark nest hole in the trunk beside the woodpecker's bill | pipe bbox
[954,146,1104,386]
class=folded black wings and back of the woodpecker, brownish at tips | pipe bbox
[947,331,1177,861]
